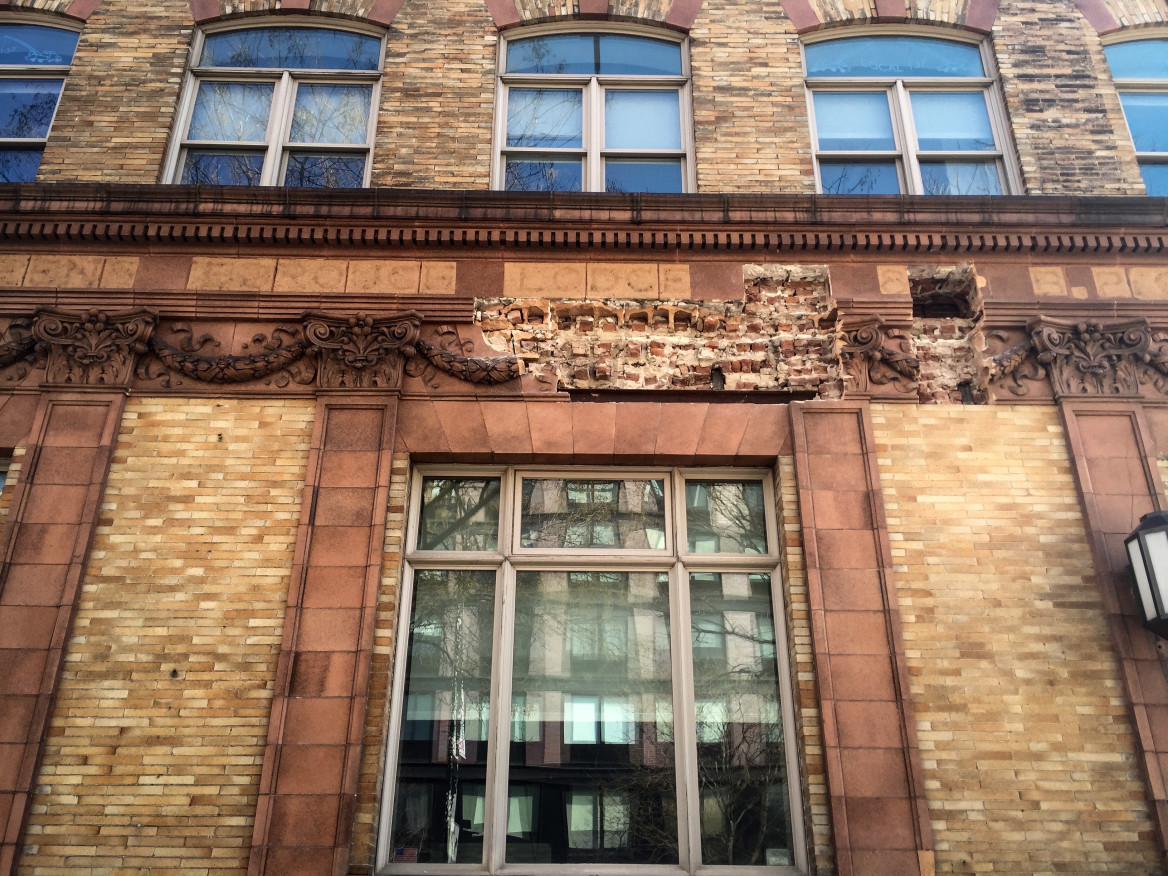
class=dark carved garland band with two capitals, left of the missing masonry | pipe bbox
[0,308,520,389]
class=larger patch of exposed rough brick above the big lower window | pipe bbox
[475,265,842,397]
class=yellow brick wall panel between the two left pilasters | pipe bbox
[19,398,314,876]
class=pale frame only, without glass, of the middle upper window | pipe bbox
[491,25,697,193]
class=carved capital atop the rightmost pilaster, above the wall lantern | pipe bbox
[1029,318,1162,398]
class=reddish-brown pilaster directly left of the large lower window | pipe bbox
[249,394,397,876]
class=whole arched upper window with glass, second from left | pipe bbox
[168,25,383,188]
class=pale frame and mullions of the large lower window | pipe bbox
[375,465,808,876]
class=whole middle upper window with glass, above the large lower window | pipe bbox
[494,33,694,192]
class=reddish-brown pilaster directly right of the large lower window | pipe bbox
[791,402,934,876]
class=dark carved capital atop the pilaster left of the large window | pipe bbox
[304,311,422,389]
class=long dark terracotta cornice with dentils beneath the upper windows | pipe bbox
[0,183,1168,257]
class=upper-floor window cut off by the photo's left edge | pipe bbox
[0,25,79,182]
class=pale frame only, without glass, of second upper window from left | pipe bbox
[162,16,385,187]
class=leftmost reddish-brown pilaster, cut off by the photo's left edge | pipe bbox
[0,391,125,876]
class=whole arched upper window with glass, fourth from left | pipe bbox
[804,36,1017,195]
